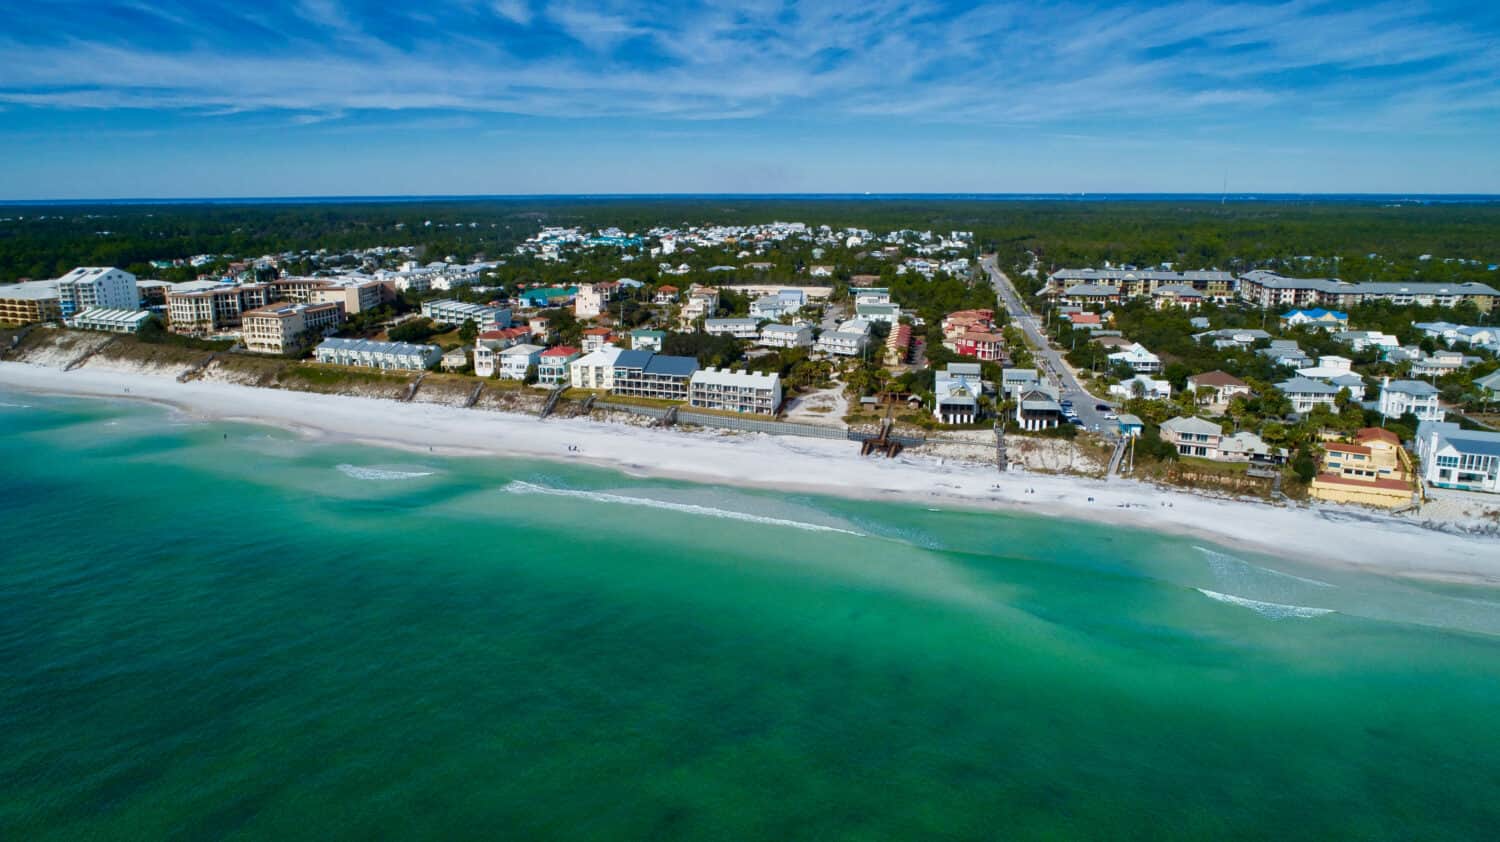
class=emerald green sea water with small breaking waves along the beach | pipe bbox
[0,393,1500,840]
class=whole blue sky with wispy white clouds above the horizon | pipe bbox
[0,0,1500,198]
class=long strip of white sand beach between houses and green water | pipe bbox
[0,363,1500,582]
